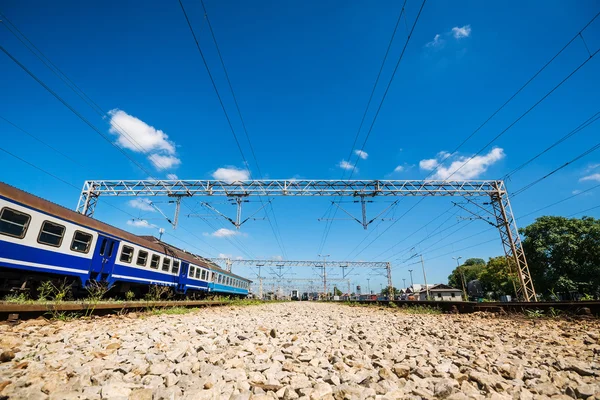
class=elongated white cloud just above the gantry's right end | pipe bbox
[426,147,505,180]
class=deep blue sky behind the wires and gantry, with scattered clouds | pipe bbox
[0,0,600,290]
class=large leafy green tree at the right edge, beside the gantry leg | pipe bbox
[520,216,600,295]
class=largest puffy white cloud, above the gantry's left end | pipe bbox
[108,108,181,170]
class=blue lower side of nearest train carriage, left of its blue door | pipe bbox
[0,240,91,282]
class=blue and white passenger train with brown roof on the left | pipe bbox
[0,182,251,296]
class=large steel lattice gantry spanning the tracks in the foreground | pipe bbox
[77,179,537,301]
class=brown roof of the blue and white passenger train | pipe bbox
[0,182,251,282]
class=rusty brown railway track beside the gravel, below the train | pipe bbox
[0,300,236,321]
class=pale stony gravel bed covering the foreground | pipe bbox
[0,302,600,400]
